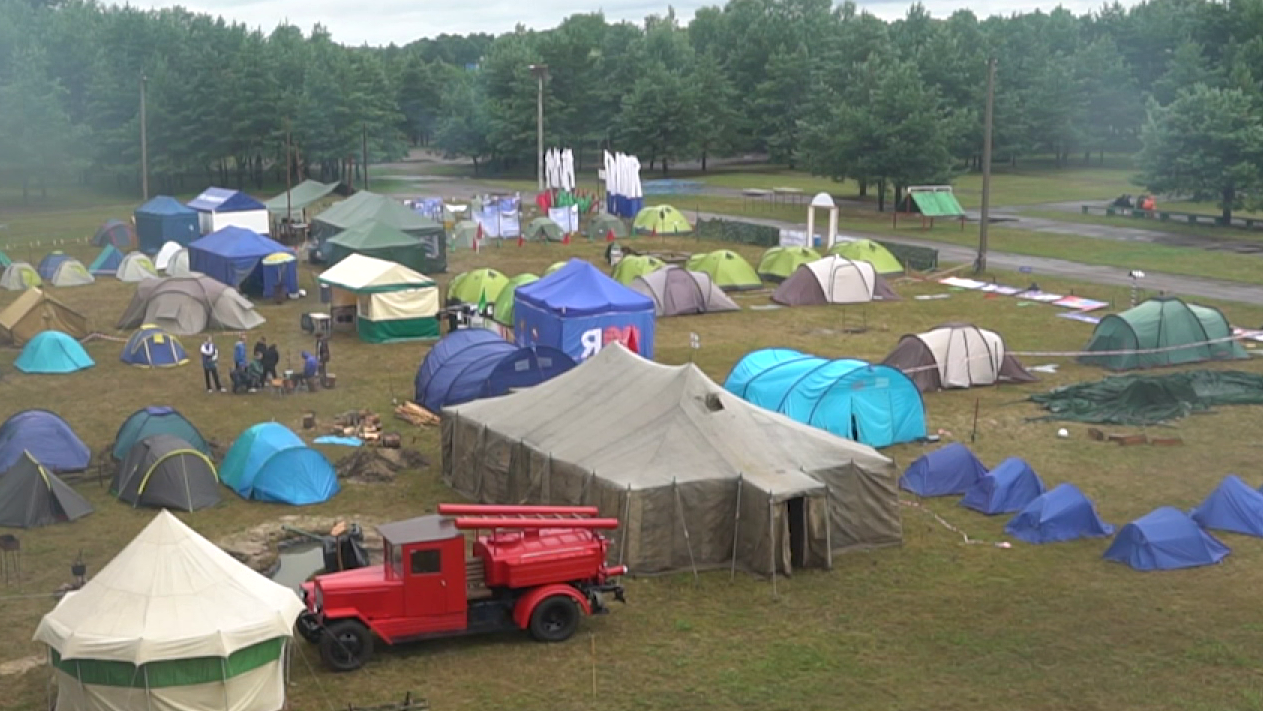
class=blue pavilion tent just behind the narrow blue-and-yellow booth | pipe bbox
[188,226,298,298]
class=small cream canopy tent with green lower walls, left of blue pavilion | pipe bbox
[320,254,440,344]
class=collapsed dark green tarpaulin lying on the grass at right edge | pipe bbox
[1031,370,1263,426]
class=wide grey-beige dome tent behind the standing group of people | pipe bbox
[117,274,264,336]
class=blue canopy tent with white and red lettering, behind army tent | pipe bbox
[513,259,654,362]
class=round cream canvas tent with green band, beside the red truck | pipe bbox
[35,510,303,711]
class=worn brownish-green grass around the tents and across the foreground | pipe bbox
[0,199,1263,711]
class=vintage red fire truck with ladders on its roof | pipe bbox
[297,504,626,672]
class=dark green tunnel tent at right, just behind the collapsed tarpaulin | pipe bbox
[1079,297,1249,370]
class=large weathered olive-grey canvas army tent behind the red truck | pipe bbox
[442,346,902,573]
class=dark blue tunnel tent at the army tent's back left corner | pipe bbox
[416,328,575,413]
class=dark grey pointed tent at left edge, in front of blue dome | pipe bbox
[0,452,92,528]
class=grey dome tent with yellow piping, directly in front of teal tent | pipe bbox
[110,434,220,511]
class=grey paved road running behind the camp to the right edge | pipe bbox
[700,212,1263,304]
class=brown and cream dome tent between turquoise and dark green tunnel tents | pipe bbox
[882,323,1036,393]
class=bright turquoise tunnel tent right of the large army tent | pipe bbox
[724,349,926,447]
